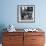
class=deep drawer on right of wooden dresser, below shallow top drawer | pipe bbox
[24,36,44,44]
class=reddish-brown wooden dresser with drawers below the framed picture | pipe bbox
[2,32,45,46]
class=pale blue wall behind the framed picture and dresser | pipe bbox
[0,0,46,28]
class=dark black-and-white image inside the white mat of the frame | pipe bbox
[21,7,33,20]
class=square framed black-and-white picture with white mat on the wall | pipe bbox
[17,5,35,23]
